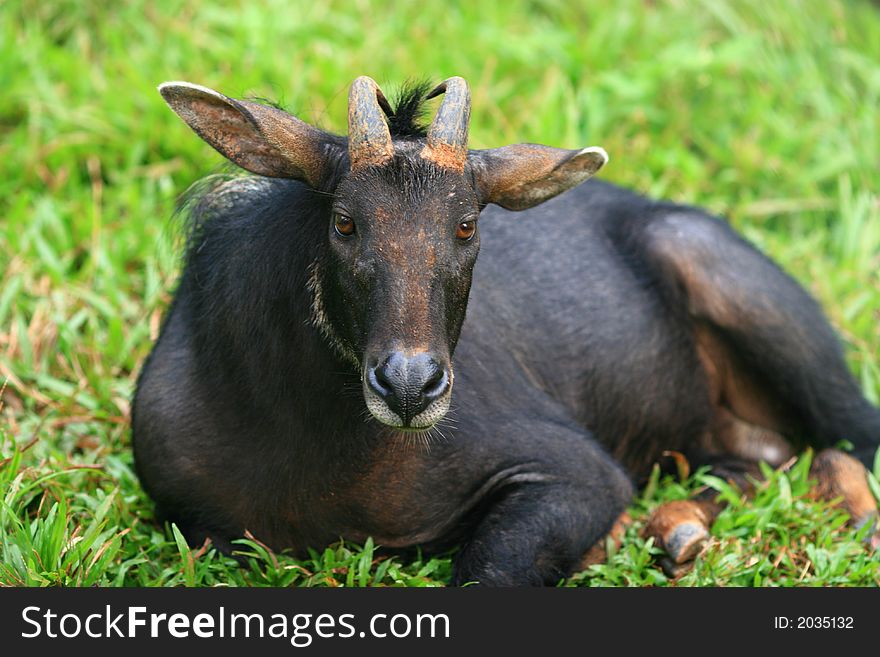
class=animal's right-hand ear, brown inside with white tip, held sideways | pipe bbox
[468,144,608,210]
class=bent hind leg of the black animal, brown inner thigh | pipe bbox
[644,209,880,465]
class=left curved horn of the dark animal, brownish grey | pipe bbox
[348,75,394,171]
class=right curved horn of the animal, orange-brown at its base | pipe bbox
[421,77,471,171]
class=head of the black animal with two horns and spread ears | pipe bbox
[159,77,607,430]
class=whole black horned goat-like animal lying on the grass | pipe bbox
[133,77,880,585]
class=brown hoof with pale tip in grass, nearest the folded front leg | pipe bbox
[645,500,710,570]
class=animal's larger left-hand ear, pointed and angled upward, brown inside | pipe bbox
[159,82,345,187]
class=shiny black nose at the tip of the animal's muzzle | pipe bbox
[367,351,450,426]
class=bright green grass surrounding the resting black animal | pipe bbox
[0,0,880,586]
